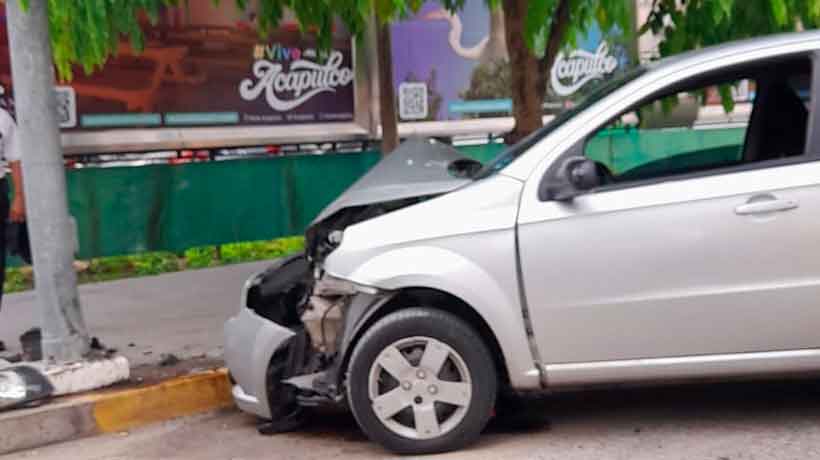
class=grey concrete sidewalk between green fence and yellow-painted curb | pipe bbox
[0,261,271,367]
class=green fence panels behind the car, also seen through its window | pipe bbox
[62,130,742,258]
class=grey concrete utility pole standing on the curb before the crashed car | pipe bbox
[5,0,89,363]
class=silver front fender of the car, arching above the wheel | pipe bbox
[324,175,540,389]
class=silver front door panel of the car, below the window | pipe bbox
[519,162,820,364]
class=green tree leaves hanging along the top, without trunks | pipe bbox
[35,0,820,138]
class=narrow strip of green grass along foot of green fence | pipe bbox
[3,236,305,293]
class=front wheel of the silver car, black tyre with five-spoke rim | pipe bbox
[347,308,498,454]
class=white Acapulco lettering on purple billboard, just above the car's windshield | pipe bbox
[550,42,618,96]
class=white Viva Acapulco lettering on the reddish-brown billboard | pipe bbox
[239,45,353,112]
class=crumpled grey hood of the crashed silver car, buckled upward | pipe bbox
[310,138,475,227]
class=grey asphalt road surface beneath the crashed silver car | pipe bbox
[9,382,820,460]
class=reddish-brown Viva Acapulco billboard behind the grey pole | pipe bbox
[0,0,354,131]
